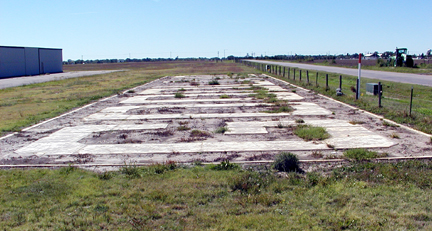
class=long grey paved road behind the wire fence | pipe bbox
[248,60,432,87]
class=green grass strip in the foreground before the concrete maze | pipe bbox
[0,161,432,230]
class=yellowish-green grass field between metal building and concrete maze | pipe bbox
[0,61,253,135]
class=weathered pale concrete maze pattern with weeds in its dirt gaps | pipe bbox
[2,76,422,166]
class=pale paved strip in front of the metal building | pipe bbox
[0,70,121,89]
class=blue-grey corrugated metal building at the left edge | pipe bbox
[0,46,63,78]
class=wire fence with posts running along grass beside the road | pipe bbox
[239,60,432,134]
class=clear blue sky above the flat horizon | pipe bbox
[0,0,432,60]
